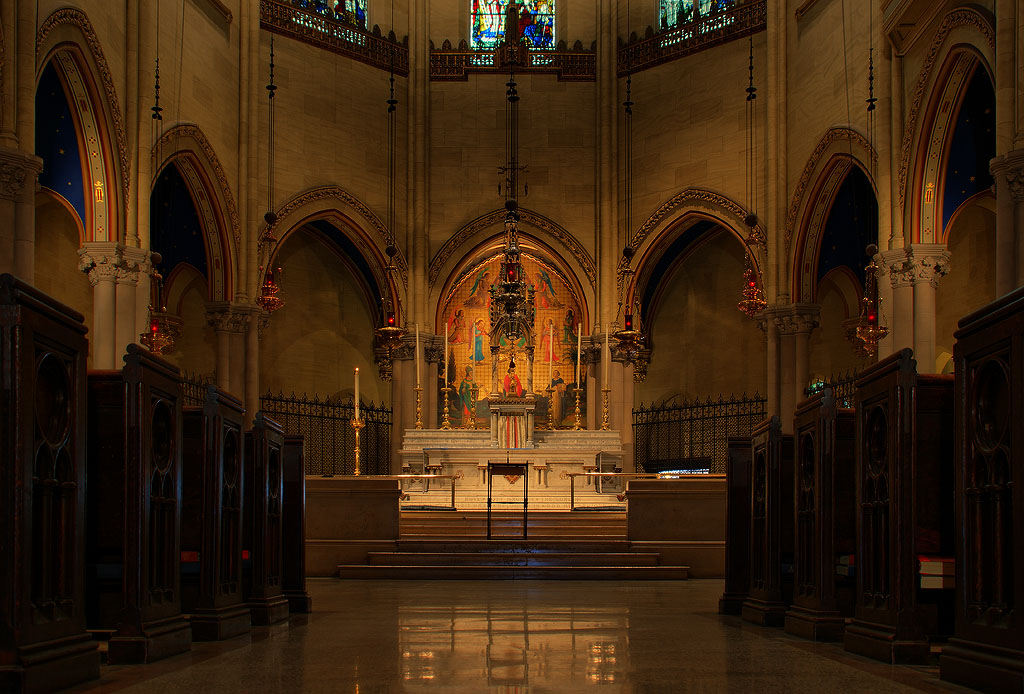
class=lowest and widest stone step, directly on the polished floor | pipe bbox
[338,564,688,580]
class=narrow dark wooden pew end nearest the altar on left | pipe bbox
[281,434,312,612]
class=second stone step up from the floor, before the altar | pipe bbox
[367,551,662,566]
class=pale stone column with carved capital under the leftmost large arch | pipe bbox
[78,247,121,370]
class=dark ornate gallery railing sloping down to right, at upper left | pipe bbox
[259,0,409,77]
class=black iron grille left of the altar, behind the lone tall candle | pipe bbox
[260,392,391,475]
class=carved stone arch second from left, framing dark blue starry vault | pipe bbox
[153,125,241,301]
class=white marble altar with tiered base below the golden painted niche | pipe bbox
[399,429,632,511]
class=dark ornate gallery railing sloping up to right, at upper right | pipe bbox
[618,0,768,77]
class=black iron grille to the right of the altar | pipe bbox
[633,393,767,474]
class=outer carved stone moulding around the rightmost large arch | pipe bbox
[896,7,995,228]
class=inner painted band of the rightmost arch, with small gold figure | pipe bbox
[903,49,995,244]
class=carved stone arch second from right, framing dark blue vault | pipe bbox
[785,128,878,301]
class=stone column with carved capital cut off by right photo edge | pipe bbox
[989,149,1024,296]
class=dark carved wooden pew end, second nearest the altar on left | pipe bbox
[242,413,289,625]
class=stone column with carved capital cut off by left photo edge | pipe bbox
[0,146,43,284]
